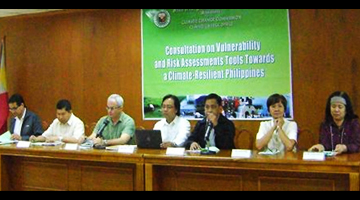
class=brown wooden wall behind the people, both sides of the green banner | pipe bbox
[0,9,360,148]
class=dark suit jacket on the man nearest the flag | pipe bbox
[10,109,44,141]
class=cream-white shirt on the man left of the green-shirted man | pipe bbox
[42,113,85,139]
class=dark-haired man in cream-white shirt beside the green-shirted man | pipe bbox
[30,99,85,143]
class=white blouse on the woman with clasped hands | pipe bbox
[256,119,298,151]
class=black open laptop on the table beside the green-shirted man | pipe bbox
[135,129,162,149]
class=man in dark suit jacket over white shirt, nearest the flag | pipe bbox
[8,94,44,141]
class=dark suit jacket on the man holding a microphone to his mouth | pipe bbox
[185,115,235,149]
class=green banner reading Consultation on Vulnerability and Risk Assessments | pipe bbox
[141,9,293,120]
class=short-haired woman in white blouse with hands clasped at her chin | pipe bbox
[256,94,298,152]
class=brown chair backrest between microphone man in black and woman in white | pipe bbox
[234,128,255,149]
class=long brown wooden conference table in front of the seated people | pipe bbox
[0,144,360,191]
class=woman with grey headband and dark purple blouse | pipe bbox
[309,91,360,154]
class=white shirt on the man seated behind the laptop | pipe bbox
[153,116,190,146]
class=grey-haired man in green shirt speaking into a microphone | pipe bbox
[89,94,135,146]
